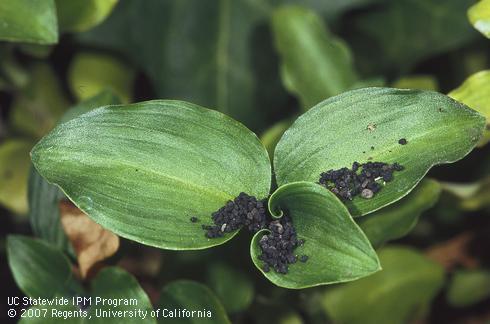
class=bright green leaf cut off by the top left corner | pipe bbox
[0,0,58,44]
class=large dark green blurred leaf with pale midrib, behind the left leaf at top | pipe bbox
[75,0,267,126]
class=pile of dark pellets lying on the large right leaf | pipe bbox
[318,162,403,200]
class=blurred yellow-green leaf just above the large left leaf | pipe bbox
[68,52,134,103]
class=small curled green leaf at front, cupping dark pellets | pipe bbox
[250,182,381,289]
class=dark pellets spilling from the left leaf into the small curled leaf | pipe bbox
[191,192,308,274]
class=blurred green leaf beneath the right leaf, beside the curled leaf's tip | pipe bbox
[357,179,441,248]
